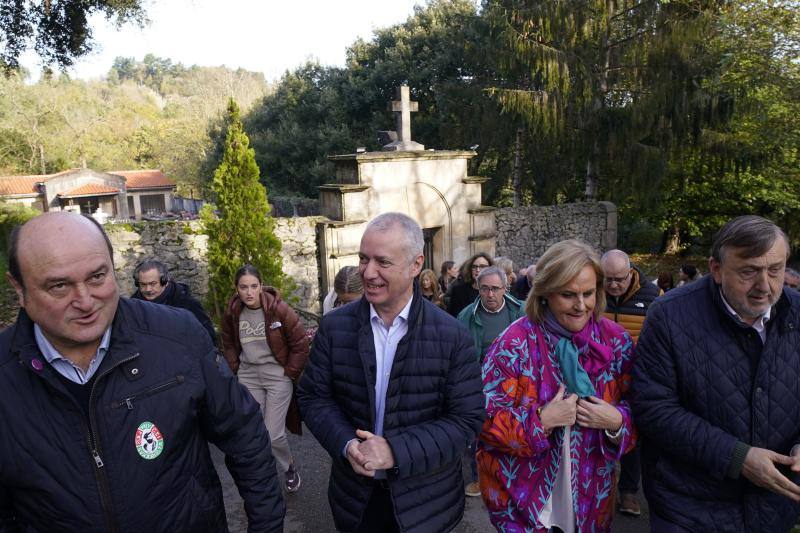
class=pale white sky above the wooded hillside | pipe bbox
[22,0,425,80]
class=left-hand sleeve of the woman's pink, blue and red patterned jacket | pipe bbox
[480,327,550,457]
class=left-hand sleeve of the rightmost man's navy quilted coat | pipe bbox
[629,302,743,480]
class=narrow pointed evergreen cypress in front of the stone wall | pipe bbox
[202,98,293,319]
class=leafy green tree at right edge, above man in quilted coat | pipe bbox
[649,0,800,252]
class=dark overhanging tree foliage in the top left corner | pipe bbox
[0,0,145,72]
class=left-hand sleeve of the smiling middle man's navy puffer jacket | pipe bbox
[297,320,356,461]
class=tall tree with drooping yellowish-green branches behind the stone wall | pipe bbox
[484,0,723,199]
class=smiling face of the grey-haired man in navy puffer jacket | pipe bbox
[358,225,423,321]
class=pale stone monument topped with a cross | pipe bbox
[317,86,496,295]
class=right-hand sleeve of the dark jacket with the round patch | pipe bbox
[198,330,285,533]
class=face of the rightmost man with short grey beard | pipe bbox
[709,237,787,324]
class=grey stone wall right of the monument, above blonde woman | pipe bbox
[495,202,617,268]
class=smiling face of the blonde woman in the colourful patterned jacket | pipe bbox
[545,265,597,333]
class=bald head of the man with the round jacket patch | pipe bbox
[7,212,119,362]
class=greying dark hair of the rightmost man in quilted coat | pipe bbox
[711,215,791,263]
